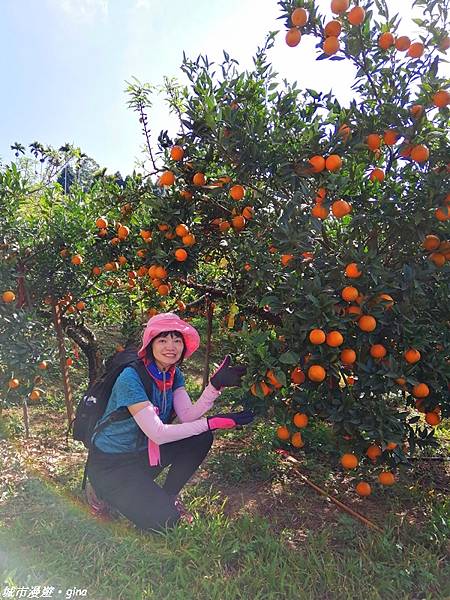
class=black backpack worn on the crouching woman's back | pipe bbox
[72,347,152,449]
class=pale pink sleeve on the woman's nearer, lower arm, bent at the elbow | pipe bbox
[133,404,208,445]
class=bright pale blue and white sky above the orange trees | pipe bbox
[0,0,444,174]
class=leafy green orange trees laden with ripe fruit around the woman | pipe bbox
[0,0,450,496]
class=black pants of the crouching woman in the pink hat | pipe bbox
[87,431,213,530]
